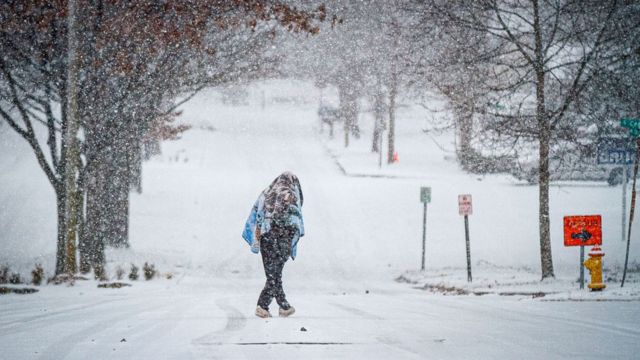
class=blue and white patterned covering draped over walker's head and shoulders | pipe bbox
[242,172,304,259]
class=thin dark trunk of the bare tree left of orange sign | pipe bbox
[533,0,555,280]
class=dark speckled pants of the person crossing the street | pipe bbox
[258,225,295,310]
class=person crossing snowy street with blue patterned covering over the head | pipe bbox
[242,172,304,318]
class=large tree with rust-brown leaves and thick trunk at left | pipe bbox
[0,0,325,274]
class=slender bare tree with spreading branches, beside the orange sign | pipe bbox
[431,0,638,279]
